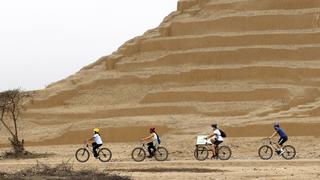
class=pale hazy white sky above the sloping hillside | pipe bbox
[0,0,178,91]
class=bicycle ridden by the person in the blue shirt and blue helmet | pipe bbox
[258,138,296,160]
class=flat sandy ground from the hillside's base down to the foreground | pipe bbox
[0,135,320,179]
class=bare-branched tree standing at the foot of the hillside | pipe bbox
[0,89,30,154]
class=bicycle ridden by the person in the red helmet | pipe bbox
[131,143,168,162]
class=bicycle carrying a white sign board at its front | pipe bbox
[193,136,232,161]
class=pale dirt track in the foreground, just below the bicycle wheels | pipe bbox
[0,159,320,179]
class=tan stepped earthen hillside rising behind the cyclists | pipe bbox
[0,0,320,155]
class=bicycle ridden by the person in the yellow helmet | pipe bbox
[75,143,112,163]
